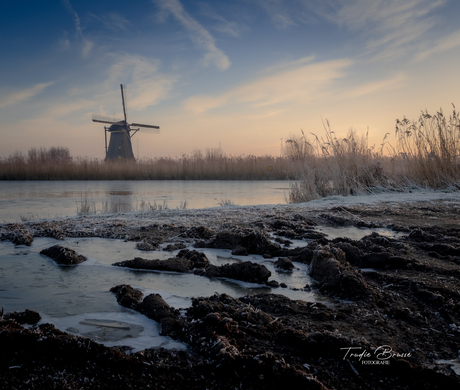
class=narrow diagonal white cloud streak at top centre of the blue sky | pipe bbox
[153,0,231,70]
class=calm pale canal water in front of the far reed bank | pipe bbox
[0,180,289,222]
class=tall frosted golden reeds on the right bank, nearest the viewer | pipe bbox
[287,106,460,203]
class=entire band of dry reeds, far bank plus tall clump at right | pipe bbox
[0,106,460,204]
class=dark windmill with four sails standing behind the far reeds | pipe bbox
[93,84,160,161]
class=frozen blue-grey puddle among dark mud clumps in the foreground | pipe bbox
[0,238,318,351]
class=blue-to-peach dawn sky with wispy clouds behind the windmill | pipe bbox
[0,0,460,158]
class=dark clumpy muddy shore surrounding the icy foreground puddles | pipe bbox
[0,200,460,389]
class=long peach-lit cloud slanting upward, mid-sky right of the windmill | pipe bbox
[185,59,352,114]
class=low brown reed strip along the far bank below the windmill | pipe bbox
[0,154,303,180]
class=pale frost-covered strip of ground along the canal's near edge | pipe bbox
[11,190,460,236]
